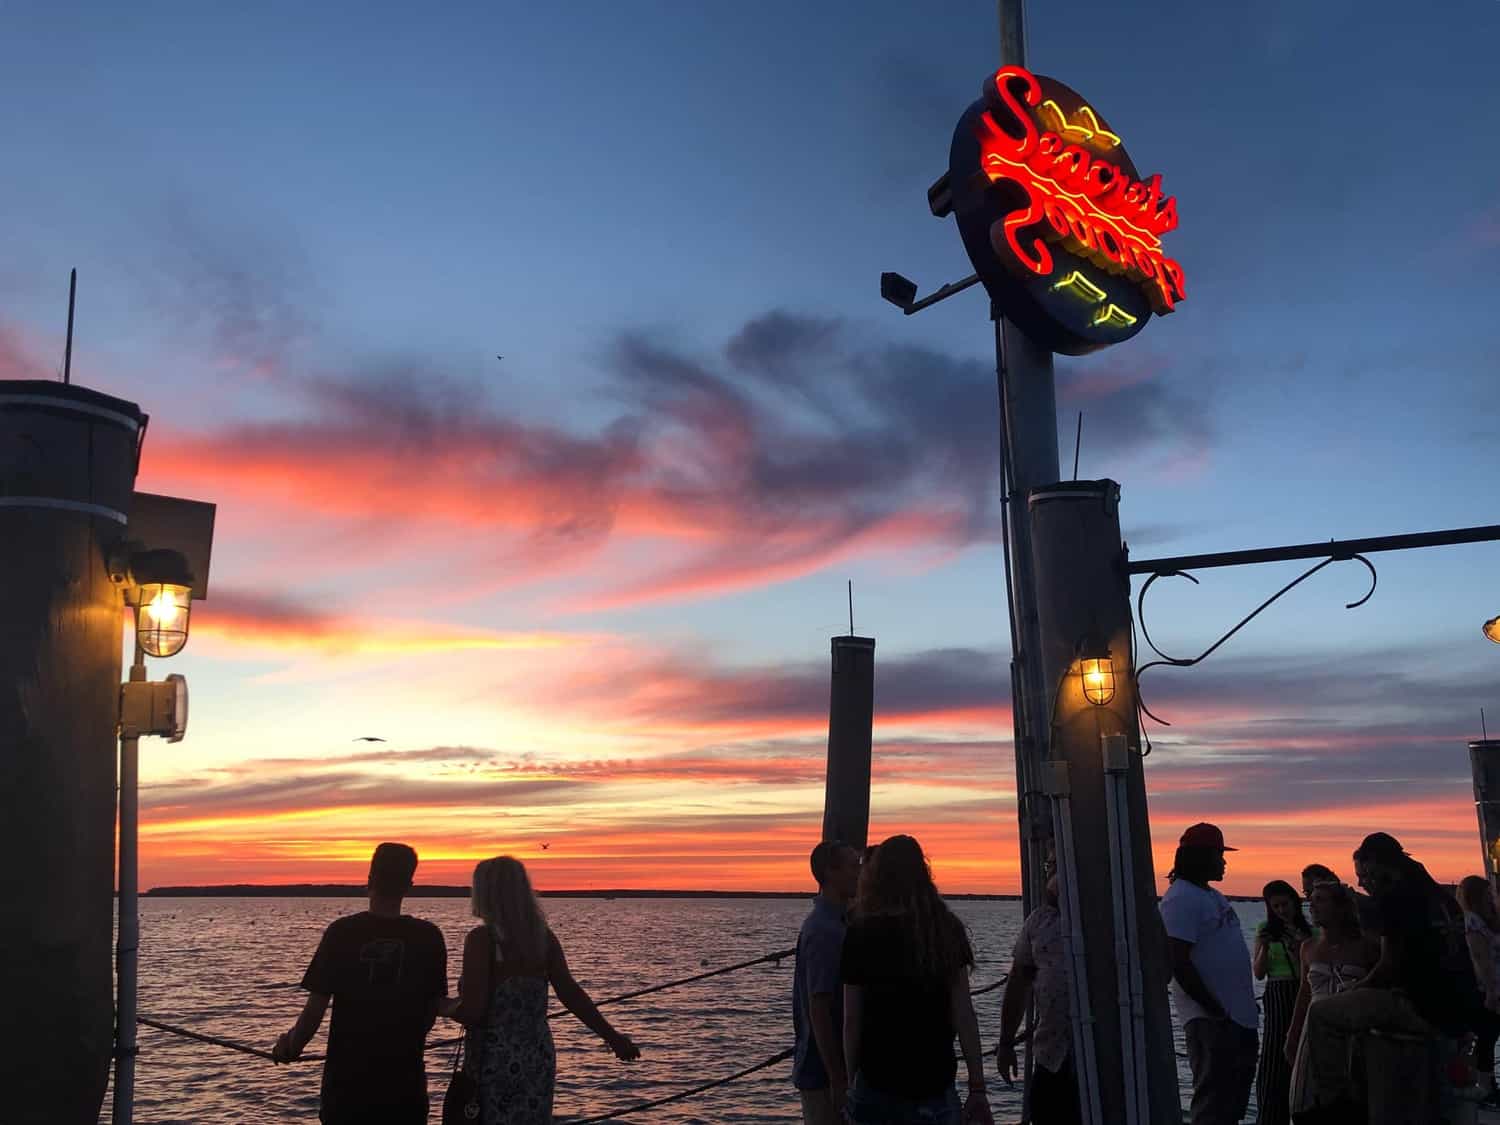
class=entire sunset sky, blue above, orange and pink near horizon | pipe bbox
[0,0,1500,893]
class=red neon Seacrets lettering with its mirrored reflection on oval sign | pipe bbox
[980,66,1187,314]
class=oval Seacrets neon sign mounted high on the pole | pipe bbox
[948,66,1187,356]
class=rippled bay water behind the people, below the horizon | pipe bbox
[101,899,1259,1125]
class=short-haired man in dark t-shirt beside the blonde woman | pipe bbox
[272,843,449,1125]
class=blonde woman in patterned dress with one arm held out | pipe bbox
[440,855,641,1125]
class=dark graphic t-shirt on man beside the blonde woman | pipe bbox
[302,912,449,1122]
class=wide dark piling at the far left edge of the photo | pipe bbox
[0,381,146,1125]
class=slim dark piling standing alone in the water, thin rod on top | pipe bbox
[824,636,875,848]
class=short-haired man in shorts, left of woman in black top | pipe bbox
[792,840,860,1125]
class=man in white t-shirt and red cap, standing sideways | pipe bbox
[1161,824,1260,1125]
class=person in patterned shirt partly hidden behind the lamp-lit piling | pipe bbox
[995,849,1080,1125]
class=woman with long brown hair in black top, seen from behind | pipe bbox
[840,836,990,1125]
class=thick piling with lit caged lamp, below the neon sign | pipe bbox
[1028,480,1181,1125]
